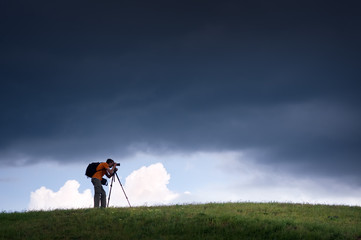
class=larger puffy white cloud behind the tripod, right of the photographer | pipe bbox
[109,163,179,206]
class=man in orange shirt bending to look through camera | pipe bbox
[92,159,117,208]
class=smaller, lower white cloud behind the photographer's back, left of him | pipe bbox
[28,180,93,210]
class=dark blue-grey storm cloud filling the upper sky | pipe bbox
[0,1,361,179]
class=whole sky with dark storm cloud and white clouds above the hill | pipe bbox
[0,0,361,211]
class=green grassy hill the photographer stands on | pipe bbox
[0,203,361,240]
